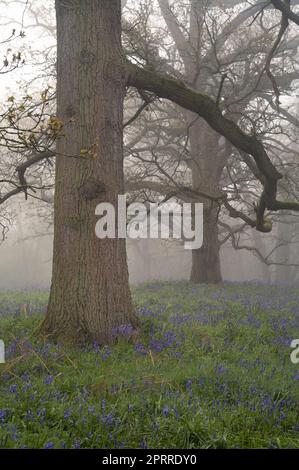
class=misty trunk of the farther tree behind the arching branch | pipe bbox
[189,119,225,284]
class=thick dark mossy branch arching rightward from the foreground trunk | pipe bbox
[126,62,299,232]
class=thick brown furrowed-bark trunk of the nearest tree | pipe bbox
[42,0,136,344]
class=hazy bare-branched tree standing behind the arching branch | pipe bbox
[124,0,299,283]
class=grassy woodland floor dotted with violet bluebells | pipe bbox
[0,283,299,449]
